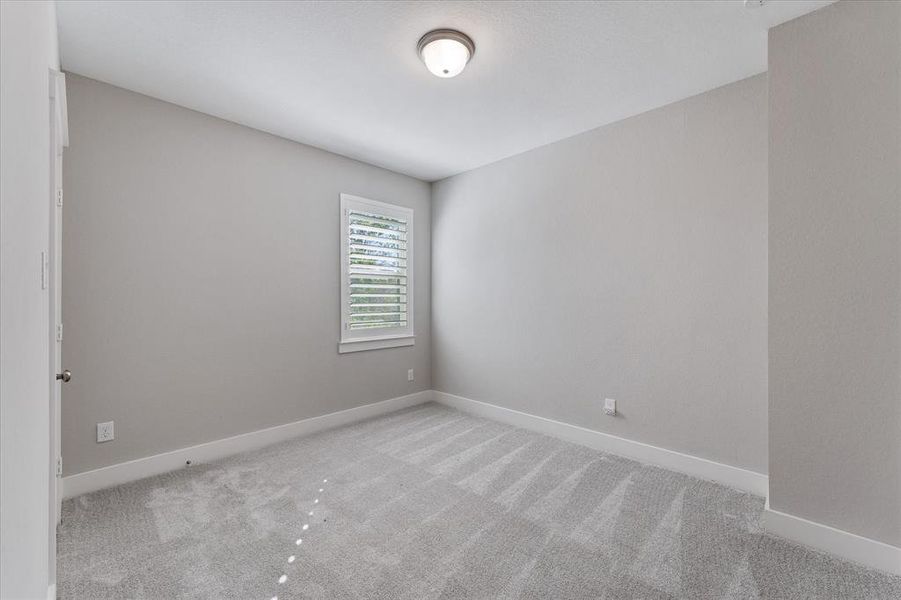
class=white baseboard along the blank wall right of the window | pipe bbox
[434,391,769,496]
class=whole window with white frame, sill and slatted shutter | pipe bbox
[338,194,413,353]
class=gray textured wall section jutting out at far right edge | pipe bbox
[769,2,901,545]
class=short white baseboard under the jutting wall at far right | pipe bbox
[761,498,901,575]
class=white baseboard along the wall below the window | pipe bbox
[62,390,432,498]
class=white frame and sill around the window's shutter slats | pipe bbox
[338,194,415,354]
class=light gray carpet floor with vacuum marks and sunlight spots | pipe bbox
[58,404,901,600]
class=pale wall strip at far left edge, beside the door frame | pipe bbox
[0,2,59,599]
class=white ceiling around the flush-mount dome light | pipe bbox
[58,0,832,181]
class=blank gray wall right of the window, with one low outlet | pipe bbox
[432,75,767,473]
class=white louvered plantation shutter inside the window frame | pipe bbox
[345,207,409,334]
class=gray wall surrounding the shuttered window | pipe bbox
[62,75,431,475]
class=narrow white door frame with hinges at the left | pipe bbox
[48,69,69,586]
